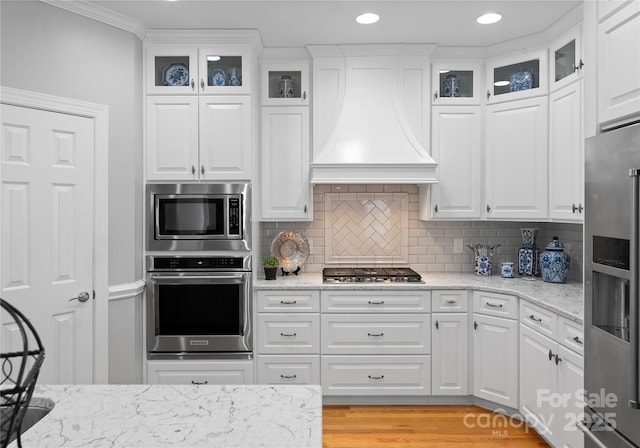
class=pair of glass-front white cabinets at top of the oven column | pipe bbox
[145,43,252,95]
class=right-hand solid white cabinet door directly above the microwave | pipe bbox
[200,96,252,180]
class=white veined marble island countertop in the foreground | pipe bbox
[10,385,322,448]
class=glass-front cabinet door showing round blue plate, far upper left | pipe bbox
[145,47,198,95]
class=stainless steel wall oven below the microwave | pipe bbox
[146,255,253,359]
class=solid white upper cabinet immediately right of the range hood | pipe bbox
[428,103,484,220]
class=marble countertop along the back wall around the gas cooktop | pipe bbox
[254,273,584,323]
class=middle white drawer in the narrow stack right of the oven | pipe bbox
[256,314,320,354]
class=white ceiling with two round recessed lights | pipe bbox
[87,0,582,47]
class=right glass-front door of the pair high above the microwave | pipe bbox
[197,46,251,94]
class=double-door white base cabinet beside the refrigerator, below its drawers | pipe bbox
[520,324,584,447]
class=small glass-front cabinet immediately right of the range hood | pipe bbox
[431,61,482,106]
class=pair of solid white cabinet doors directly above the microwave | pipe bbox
[146,95,252,181]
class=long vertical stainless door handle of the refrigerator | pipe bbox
[629,168,640,409]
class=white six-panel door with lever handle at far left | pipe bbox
[0,105,94,384]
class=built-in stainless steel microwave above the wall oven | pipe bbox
[146,183,251,251]
